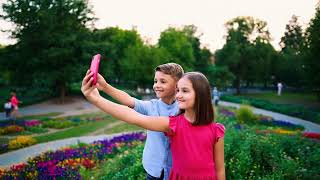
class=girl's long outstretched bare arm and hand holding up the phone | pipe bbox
[81,73,169,132]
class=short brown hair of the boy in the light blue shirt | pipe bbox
[155,63,184,81]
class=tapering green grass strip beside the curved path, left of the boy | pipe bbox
[35,120,113,143]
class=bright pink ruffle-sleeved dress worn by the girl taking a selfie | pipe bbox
[166,114,225,180]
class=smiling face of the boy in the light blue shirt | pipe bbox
[153,71,177,98]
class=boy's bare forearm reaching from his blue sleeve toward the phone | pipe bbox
[97,74,134,108]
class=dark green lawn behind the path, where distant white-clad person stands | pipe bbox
[241,92,320,111]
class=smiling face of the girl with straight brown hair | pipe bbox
[176,78,196,110]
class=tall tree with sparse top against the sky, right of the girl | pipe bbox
[216,17,270,94]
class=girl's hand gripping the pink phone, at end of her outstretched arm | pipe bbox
[81,70,100,104]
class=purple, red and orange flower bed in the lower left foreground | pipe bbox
[0,133,145,179]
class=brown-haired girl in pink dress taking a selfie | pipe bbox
[81,72,225,180]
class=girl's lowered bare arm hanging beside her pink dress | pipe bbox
[213,138,226,180]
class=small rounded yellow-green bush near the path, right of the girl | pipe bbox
[236,105,256,124]
